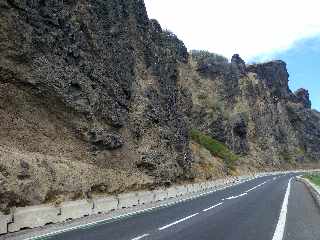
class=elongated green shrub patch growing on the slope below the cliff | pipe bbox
[190,129,239,170]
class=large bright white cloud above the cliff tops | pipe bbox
[145,0,320,60]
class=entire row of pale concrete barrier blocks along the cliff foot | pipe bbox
[0,170,319,235]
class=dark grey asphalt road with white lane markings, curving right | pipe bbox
[45,174,320,240]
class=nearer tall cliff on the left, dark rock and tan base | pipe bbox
[0,0,192,209]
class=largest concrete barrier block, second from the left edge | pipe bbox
[8,204,60,232]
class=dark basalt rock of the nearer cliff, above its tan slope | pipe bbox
[0,0,192,186]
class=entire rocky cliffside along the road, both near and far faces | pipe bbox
[0,0,320,211]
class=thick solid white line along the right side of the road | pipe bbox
[272,178,292,240]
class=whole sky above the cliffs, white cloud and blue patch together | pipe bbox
[145,0,320,110]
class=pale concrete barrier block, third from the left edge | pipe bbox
[59,200,93,222]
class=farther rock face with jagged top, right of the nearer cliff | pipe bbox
[182,55,320,167]
